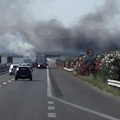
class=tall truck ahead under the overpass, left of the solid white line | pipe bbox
[36,54,47,68]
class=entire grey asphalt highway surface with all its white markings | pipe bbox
[0,65,120,120]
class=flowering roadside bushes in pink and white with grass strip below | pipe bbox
[56,51,120,96]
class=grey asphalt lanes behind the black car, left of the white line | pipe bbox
[0,69,48,120]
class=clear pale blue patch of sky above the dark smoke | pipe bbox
[31,0,104,27]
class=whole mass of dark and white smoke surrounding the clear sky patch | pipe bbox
[0,0,120,56]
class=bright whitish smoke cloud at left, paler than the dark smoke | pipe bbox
[0,33,35,57]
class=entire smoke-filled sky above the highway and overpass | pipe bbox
[0,0,120,56]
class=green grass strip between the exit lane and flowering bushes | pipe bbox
[63,69,120,96]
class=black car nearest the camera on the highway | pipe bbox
[15,66,32,81]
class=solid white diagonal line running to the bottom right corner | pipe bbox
[51,97,120,120]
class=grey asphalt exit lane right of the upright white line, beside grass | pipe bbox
[50,66,120,120]
